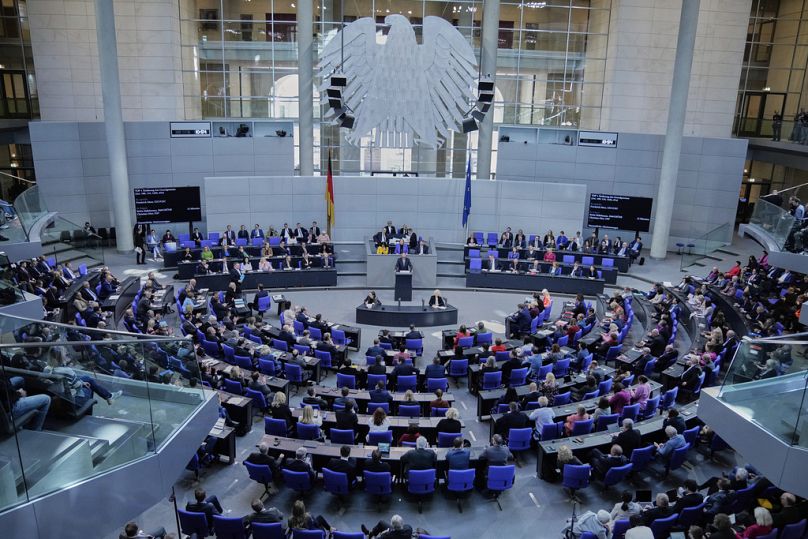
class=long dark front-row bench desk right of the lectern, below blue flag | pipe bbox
[466,271,605,295]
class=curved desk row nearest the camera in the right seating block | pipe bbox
[536,401,698,481]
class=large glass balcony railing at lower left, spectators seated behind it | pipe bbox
[0,316,211,512]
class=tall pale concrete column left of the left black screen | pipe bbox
[95,0,134,253]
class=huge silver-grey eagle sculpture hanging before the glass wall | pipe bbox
[319,15,477,148]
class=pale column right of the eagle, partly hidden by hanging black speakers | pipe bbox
[477,0,499,180]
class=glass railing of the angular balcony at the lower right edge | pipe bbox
[718,333,808,448]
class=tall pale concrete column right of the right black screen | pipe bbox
[651,0,700,258]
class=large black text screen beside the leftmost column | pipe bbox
[135,187,202,224]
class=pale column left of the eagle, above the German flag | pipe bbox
[297,0,314,176]
